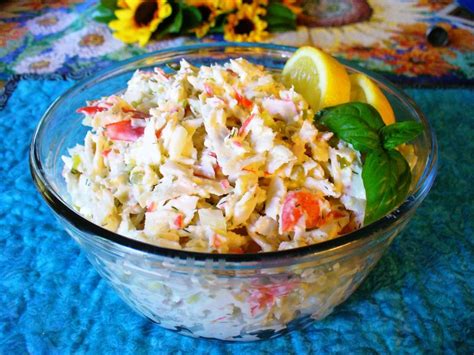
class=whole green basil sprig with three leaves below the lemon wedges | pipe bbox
[314,102,416,224]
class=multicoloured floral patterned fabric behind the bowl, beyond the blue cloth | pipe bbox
[0,0,474,108]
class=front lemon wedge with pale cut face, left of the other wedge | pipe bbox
[282,46,351,111]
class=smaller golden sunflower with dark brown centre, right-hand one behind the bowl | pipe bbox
[224,4,268,42]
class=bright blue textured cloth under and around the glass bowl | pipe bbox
[0,80,474,354]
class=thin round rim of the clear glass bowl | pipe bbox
[29,42,438,263]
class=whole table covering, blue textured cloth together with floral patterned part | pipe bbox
[0,0,474,354]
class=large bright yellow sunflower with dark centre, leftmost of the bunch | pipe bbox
[109,0,172,46]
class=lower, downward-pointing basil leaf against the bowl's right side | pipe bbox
[362,150,411,225]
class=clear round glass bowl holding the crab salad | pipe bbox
[30,43,437,341]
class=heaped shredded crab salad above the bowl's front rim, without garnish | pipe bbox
[63,59,365,253]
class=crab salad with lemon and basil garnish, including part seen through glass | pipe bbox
[55,47,423,341]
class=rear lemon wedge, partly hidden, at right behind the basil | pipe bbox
[349,73,395,125]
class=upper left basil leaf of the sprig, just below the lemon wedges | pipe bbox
[315,102,384,153]
